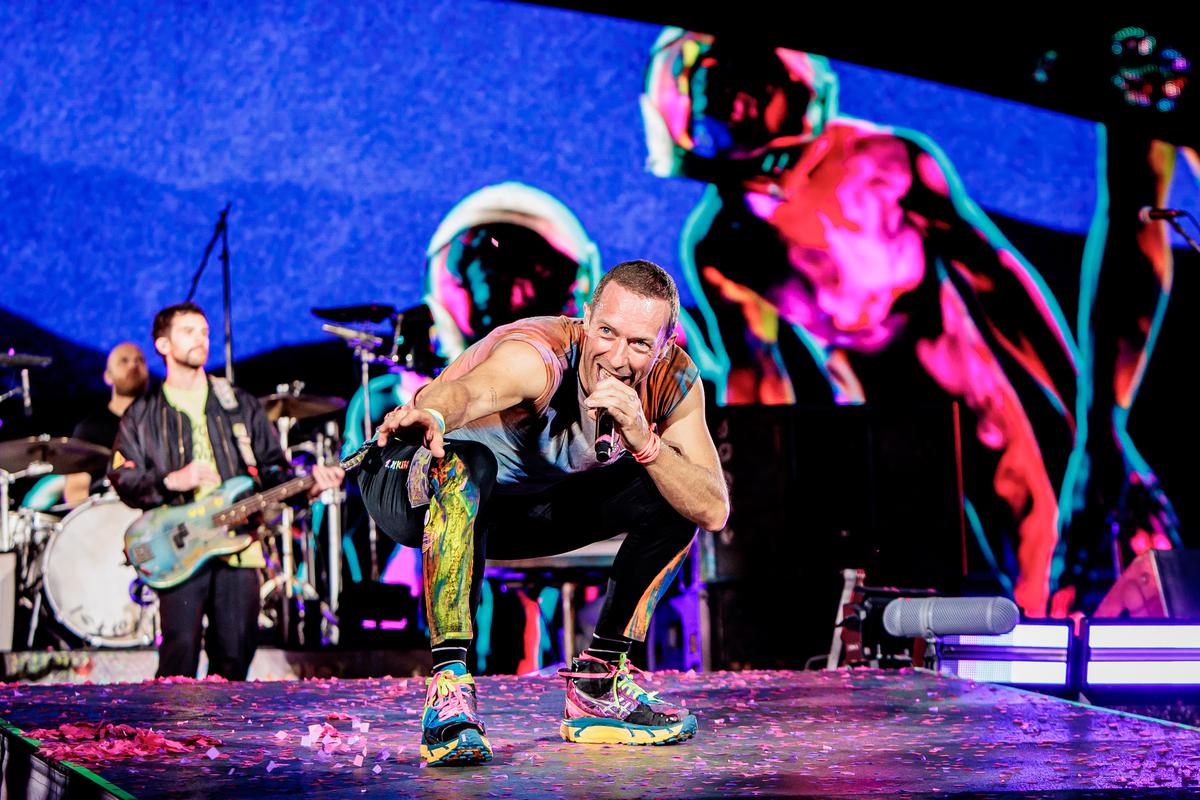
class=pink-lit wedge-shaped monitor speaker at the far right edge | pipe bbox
[1094,551,1200,619]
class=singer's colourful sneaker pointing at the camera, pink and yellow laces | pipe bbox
[421,663,492,766]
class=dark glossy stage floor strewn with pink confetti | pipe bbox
[0,670,1200,798]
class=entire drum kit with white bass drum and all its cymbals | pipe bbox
[0,303,444,648]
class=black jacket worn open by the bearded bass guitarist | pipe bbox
[108,377,289,509]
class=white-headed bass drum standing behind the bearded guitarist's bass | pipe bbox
[42,495,158,648]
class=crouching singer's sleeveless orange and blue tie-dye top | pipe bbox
[427,317,698,494]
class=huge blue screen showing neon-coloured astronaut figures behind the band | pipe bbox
[0,0,1200,615]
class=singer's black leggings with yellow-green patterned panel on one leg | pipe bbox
[359,441,696,645]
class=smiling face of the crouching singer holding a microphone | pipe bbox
[580,283,671,395]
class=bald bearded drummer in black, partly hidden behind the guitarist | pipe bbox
[62,342,150,506]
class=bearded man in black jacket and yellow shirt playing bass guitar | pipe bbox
[108,302,344,680]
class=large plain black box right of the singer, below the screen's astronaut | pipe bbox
[701,403,964,668]
